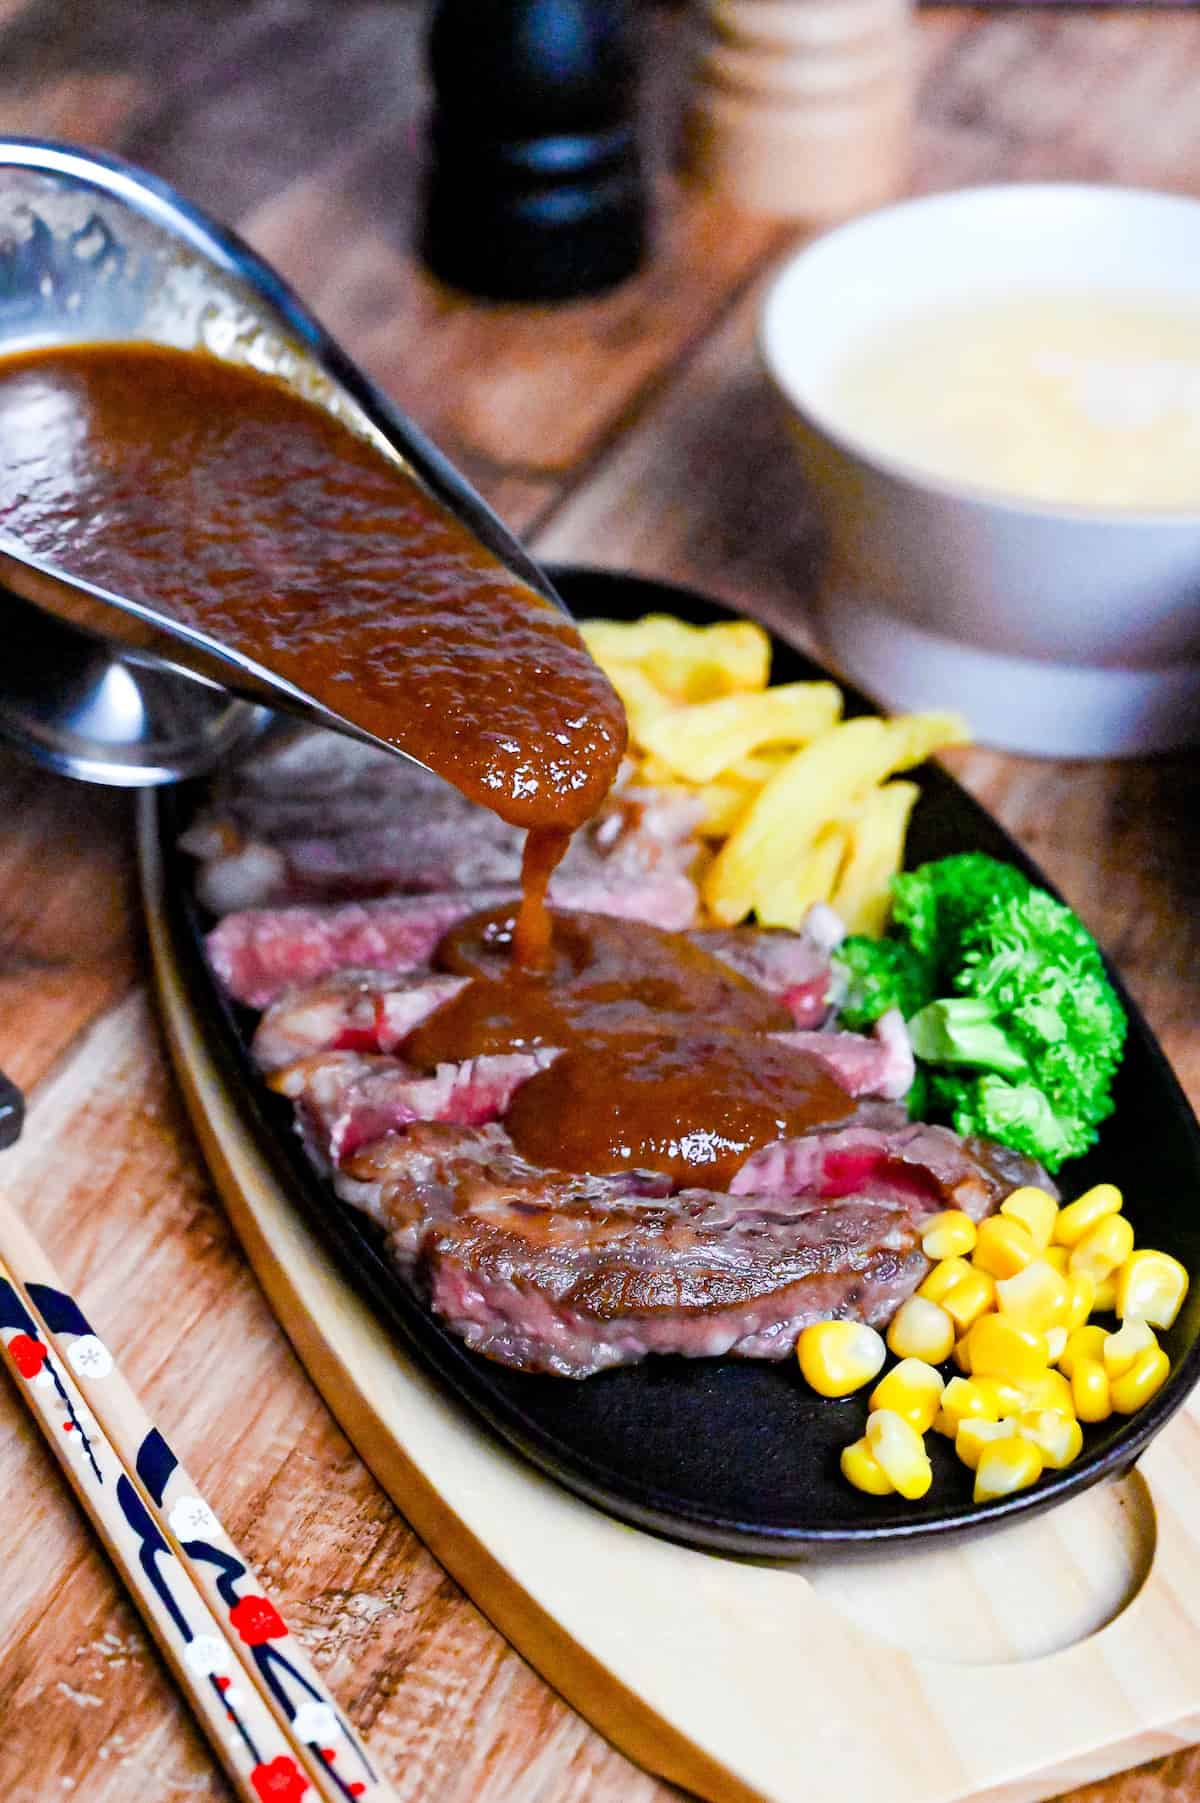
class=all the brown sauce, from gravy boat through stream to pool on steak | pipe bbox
[0,344,852,1185]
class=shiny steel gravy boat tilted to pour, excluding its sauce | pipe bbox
[0,139,566,786]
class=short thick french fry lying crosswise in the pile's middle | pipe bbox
[645,682,841,783]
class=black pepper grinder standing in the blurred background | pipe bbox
[422,0,647,301]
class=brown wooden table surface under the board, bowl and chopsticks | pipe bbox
[0,0,1200,1803]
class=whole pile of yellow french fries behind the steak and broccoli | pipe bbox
[580,615,968,934]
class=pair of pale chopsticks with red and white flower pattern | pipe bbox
[0,1195,393,1803]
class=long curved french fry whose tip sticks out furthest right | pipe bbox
[705,714,966,927]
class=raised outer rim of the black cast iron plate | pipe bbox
[153,564,1200,1558]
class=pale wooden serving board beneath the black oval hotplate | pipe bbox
[139,797,1200,1803]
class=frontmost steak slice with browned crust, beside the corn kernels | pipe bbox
[327,1103,972,1377]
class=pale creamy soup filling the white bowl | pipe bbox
[818,292,1200,510]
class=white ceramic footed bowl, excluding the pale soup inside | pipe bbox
[760,184,1200,757]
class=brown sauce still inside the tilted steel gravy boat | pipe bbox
[0,344,625,829]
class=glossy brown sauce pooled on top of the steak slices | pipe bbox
[402,909,854,1188]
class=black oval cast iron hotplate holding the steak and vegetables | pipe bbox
[152,570,1200,1558]
